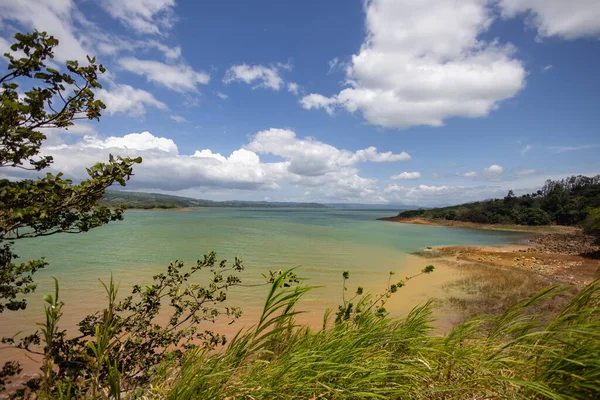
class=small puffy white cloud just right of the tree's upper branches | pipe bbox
[97,85,168,117]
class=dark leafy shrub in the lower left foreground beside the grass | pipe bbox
[3,253,248,398]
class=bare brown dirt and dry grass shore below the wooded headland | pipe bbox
[416,231,600,319]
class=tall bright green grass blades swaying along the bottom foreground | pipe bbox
[147,270,600,399]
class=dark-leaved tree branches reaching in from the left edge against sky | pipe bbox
[0,31,142,313]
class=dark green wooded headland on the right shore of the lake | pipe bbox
[398,175,600,225]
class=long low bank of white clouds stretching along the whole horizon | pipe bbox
[17,129,590,206]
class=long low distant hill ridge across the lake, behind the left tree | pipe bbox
[100,190,328,209]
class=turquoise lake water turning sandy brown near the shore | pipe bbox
[0,208,523,333]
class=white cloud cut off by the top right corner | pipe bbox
[498,0,600,39]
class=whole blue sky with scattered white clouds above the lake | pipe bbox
[0,0,600,206]
